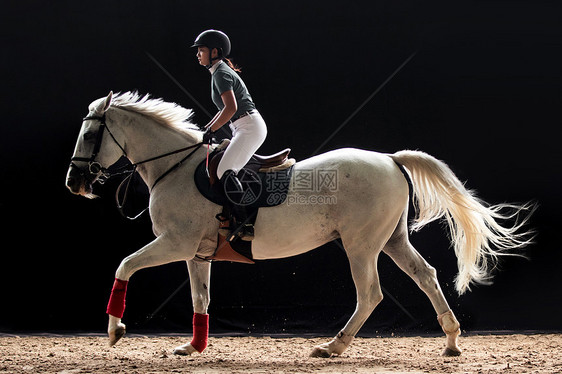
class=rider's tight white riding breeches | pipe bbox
[217,111,267,179]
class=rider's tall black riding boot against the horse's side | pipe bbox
[221,170,254,241]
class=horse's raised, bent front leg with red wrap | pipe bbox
[107,235,195,346]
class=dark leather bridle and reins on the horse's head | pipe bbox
[70,113,204,219]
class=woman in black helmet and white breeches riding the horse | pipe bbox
[192,30,267,240]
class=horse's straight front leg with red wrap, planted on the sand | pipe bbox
[174,259,211,356]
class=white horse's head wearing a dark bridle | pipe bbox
[66,92,124,198]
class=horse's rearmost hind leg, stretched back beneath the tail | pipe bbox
[383,211,461,356]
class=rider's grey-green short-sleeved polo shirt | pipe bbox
[211,61,256,119]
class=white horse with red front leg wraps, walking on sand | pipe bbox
[66,92,532,357]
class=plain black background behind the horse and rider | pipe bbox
[0,0,562,335]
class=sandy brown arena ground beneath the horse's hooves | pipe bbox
[0,334,562,374]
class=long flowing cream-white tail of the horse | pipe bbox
[389,151,536,294]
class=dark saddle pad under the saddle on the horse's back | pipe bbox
[194,160,294,209]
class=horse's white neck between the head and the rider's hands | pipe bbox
[107,109,198,190]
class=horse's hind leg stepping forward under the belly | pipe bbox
[310,237,383,358]
